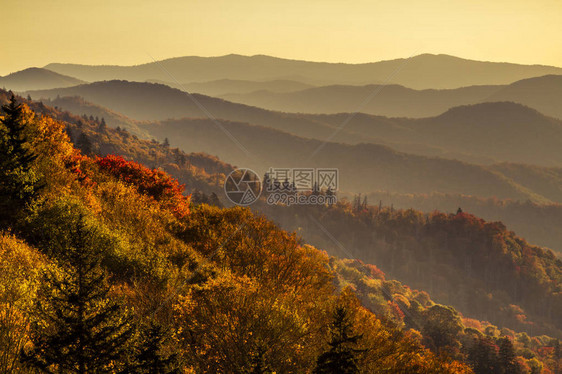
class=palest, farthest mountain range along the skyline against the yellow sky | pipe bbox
[45,54,562,89]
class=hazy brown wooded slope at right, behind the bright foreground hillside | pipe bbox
[261,201,562,337]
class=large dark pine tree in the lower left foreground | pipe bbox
[21,216,133,373]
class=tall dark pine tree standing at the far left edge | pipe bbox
[0,94,42,225]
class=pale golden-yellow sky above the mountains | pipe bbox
[0,0,562,75]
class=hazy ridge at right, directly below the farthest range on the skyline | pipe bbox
[219,75,562,118]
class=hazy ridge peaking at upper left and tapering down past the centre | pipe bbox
[28,81,372,142]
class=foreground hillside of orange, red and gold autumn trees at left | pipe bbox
[0,95,470,373]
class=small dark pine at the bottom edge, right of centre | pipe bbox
[314,307,363,374]
